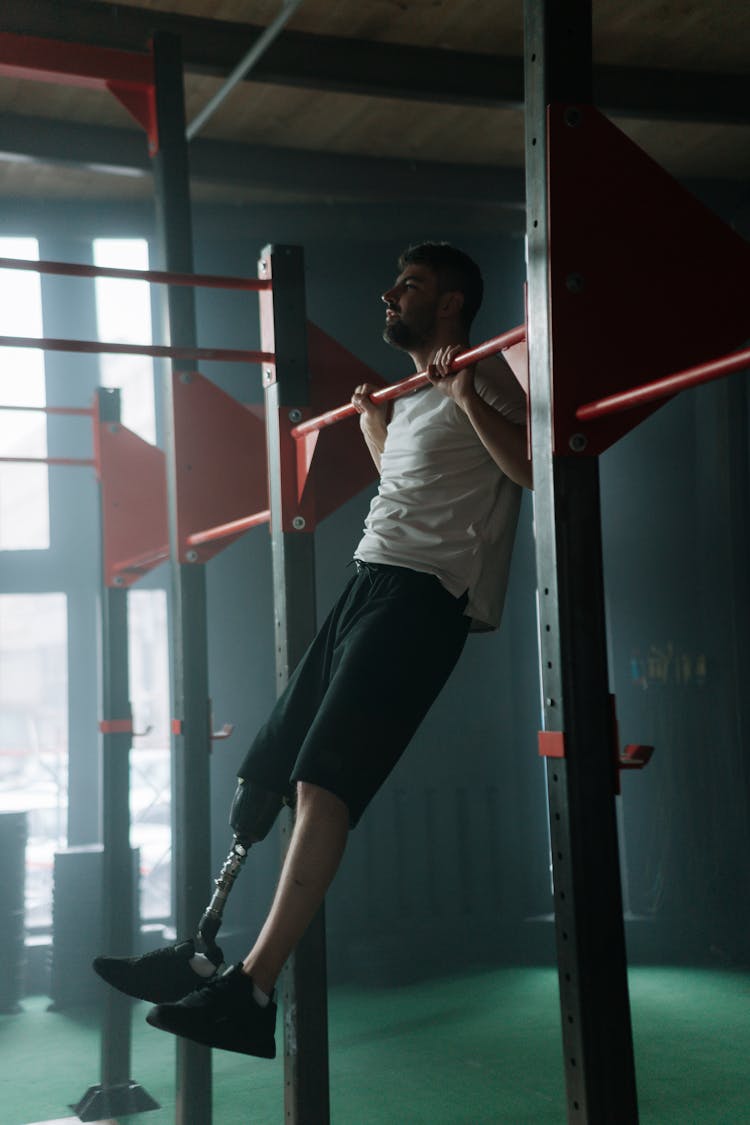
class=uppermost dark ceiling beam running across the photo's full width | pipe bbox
[5,0,750,125]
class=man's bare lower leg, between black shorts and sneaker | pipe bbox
[243,782,349,996]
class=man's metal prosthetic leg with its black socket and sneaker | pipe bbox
[93,777,284,1004]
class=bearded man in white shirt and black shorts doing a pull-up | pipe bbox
[97,243,532,1058]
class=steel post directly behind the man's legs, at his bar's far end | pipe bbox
[259,246,329,1125]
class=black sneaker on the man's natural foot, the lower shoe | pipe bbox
[146,964,277,1059]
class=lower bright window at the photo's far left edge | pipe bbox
[0,594,67,928]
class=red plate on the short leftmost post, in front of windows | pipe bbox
[93,400,169,586]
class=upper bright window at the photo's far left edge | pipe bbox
[0,237,49,550]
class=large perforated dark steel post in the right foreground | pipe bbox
[525,0,638,1125]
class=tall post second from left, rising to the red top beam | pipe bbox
[153,33,211,1125]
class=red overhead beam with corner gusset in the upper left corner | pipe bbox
[0,32,159,156]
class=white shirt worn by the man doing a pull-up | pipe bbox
[354,358,526,629]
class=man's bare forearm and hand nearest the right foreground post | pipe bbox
[427,345,534,488]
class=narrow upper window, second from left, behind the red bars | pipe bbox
[93,239,156,443]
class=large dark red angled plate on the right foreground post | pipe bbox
[548,105,750,456]
